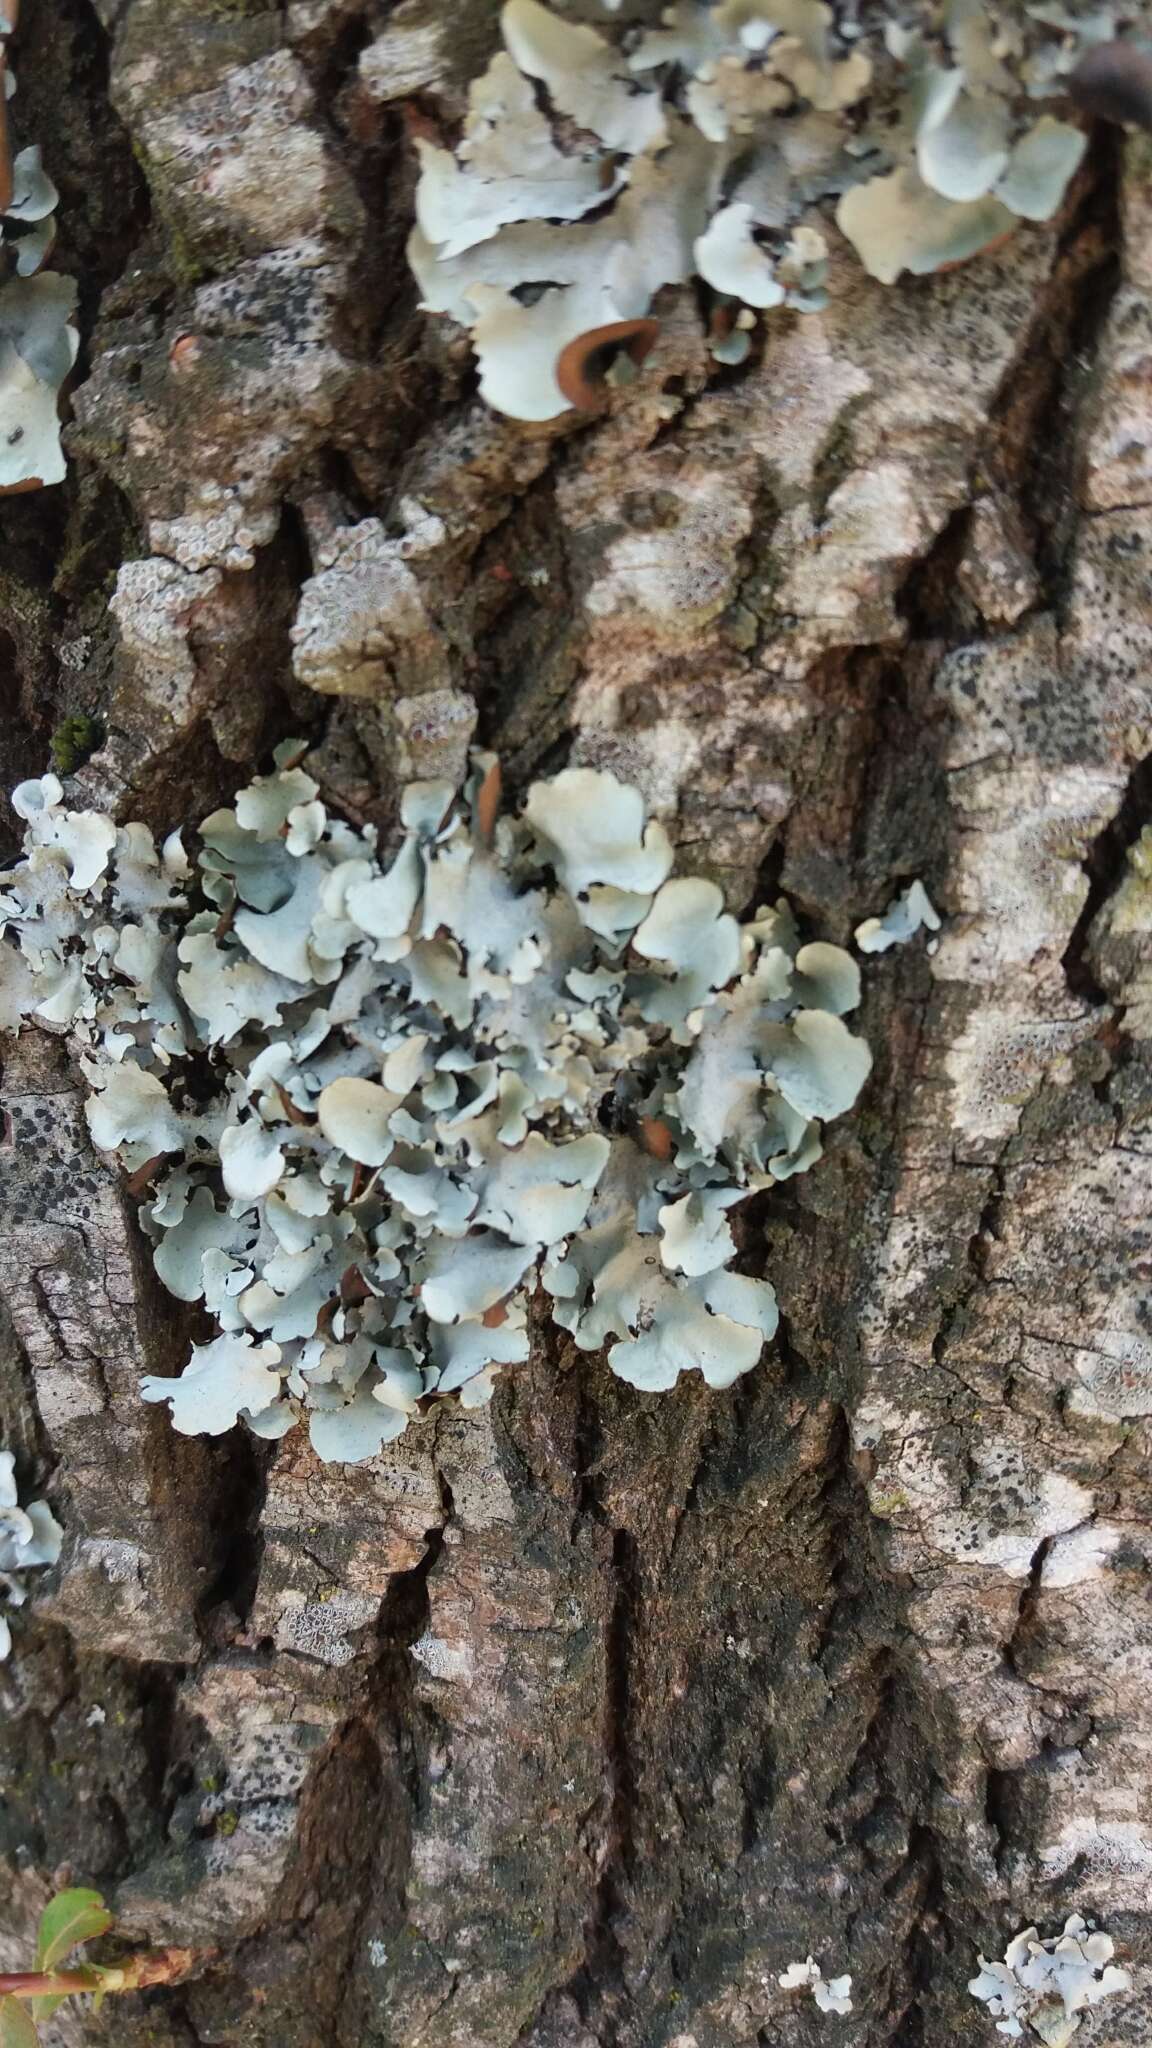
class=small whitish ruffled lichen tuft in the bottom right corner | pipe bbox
[968,1913,1132,2048]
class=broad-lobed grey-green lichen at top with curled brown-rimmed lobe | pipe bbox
[408,0,1113,420]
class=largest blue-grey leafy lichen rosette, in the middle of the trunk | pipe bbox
[0,761,871,1460]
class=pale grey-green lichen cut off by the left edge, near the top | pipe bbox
[0,0,80,496]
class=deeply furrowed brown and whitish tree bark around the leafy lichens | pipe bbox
[0,0,1152,2048]
